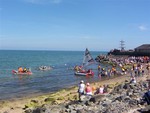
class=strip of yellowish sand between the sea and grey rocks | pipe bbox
[0,70,148,113]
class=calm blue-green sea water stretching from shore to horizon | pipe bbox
[0,50,106,100]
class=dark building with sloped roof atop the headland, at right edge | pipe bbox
[135,44,150,54]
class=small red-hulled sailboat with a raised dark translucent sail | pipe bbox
[74,48,95,76]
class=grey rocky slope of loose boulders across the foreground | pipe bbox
[25,74,150,113]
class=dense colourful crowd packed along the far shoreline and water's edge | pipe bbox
[98,57,150,78]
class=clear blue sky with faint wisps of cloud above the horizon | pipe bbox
[0,0,150,51]
